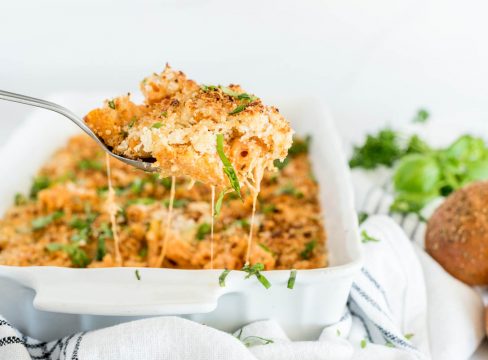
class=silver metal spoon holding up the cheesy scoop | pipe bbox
[0,90,159,172]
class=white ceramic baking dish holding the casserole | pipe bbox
[0,95,361,339]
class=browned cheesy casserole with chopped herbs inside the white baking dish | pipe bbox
[0,136,327,269]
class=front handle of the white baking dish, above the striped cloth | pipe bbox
[33,284,222,316]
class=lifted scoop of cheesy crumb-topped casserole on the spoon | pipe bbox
[85,66,293,187]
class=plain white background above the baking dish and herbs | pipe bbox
[0,0,488,358]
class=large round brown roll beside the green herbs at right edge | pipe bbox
[425,182,488,285]
